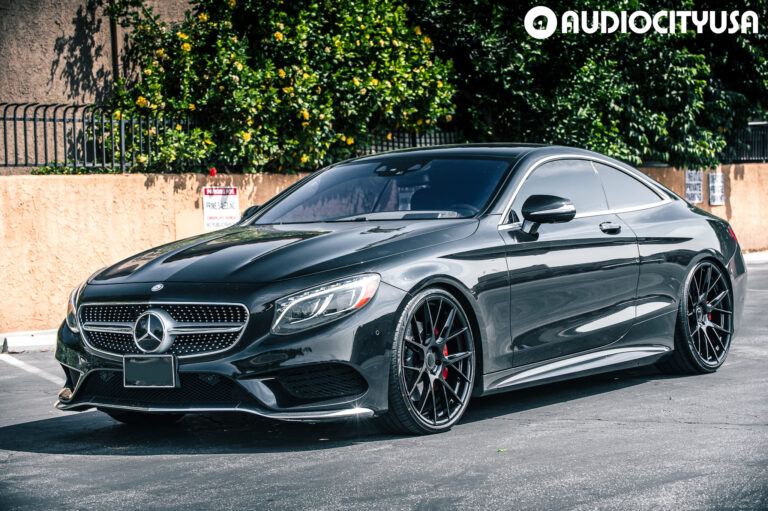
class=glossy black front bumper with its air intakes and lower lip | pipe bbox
[56,283,405,422]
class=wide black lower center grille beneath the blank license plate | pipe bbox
[73,371,254,407]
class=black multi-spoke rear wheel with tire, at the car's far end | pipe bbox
[656,260,733,374]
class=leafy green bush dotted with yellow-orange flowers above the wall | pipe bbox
[105,0,454,172]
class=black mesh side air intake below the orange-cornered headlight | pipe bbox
[277,363,368,399]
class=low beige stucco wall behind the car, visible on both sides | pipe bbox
[0,164,768,332]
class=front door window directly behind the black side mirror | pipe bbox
[512,160,608,220]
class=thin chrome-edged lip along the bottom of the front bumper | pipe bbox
[55,401,374,422]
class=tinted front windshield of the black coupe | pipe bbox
[255,156,510,224]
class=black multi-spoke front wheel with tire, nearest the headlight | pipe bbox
[380,288,475,435]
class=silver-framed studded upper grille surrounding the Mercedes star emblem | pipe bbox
[79,303,248,357]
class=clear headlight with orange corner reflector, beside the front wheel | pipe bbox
[272,273,380,335]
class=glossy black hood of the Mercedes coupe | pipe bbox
[90,219,477,285]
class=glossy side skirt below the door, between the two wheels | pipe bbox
[483,345,672,394]
